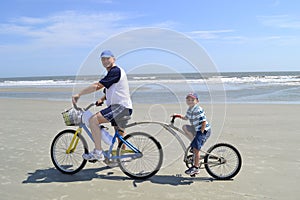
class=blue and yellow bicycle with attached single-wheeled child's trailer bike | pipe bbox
[51,103,242,180]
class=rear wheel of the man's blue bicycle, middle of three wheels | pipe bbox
[117,132,163,179]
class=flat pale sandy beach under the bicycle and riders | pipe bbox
[0,98,300,200]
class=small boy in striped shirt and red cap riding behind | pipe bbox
[173,93,211,176]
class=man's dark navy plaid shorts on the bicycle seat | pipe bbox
[100,104,132,126]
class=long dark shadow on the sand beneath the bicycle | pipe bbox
[22,167,225,187]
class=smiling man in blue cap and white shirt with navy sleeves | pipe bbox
[72,50,132,161]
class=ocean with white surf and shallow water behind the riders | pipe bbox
[0,71,300,104]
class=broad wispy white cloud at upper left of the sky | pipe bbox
[0,11,134,46]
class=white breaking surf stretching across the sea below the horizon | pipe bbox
[0,75,300,87]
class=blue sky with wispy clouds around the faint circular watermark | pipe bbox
[0,0,300,77]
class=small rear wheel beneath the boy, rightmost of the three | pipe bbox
[204,143,242,180]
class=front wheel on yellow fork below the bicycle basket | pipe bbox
[51,129,88,174]
